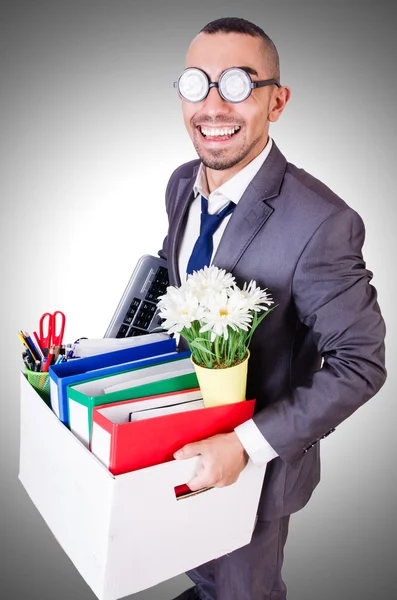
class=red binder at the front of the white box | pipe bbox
[91,392,255,475]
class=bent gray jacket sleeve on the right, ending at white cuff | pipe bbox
[254,208,386,462]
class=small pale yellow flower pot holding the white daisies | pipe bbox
[191,352,250,407]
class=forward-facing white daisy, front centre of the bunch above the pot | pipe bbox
[200,290,252,341]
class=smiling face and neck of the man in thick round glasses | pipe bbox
[178,25,284,185]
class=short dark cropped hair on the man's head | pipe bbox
[200,17,280,80]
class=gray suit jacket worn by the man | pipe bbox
[159,143,386,520]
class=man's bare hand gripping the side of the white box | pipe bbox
[174,431,248,492]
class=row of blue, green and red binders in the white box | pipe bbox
[50,334,255,475]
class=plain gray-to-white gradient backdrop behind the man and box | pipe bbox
[0,0,397,600]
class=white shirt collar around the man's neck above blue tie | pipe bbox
[193,137,273,205]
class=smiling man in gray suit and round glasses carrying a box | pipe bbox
[159,18,386,600]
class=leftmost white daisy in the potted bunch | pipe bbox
[158,286,204,333]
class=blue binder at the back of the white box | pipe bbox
[49,338,176,426]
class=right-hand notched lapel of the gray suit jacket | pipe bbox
[213,142,287,272]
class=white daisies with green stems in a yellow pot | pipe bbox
[158,266,276,406]
